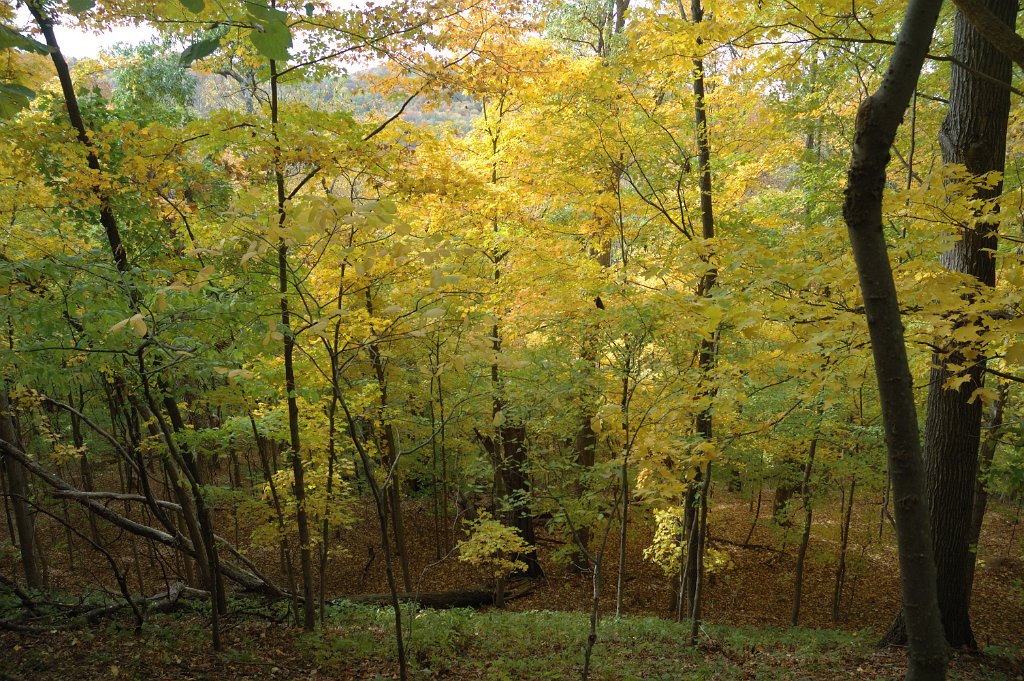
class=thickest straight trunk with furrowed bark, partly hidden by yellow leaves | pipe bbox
[925,0,1017,648]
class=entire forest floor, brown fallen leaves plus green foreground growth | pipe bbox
[0,494,1024,681]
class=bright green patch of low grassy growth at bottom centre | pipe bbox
[307,605,884,681]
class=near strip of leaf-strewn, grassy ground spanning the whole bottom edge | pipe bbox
[0,601,1024,681]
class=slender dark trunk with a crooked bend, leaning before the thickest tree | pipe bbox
[843,0,947,681]
